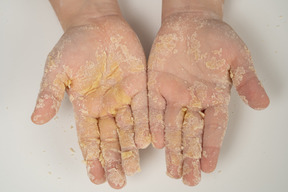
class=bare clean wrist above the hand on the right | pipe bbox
[162,0,224,21]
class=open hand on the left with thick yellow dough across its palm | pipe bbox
[32,16,150,188]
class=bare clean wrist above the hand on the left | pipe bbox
[49,0,121,31]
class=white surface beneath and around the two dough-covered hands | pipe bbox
[0,0,288,192]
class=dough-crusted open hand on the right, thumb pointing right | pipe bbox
[148,12,269,186]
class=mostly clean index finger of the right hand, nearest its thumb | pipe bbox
[201,105,228,173]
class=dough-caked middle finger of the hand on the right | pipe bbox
[182,110,204,186]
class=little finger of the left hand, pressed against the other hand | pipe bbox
[131,90,151,149]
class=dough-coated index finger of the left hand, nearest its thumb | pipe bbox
[75,112,106,184]
